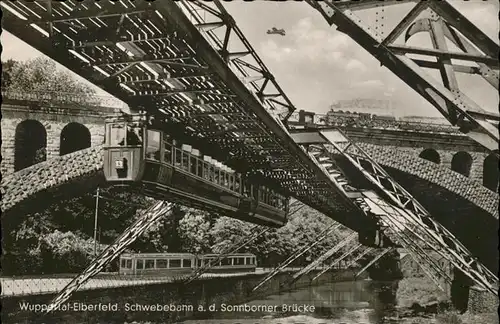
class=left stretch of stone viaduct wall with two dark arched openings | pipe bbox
[1,93,119,176]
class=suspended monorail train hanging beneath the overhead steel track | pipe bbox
[104,115,289,227]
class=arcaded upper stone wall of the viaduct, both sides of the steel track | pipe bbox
[1,93,499,192]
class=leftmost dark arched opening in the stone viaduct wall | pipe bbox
[14,119,47,171]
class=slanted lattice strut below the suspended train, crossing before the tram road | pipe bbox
[47,201,172,313]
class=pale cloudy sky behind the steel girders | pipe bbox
[0,0,499,117]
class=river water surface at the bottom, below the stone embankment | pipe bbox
[183,280,397,324]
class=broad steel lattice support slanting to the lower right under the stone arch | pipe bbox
[294,130,498,294]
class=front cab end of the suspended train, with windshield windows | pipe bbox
[103,115,146,183]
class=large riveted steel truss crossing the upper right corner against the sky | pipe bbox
[306,0,500,152]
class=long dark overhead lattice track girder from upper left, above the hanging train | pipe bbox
[0,0,371,230]
